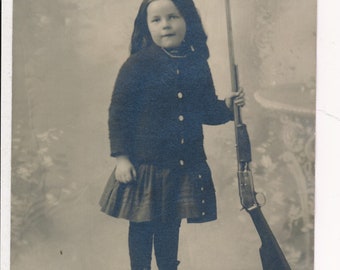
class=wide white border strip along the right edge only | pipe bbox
[315,0,340,270]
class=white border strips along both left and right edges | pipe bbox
[0,0,340,270]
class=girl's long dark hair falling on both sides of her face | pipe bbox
[130,0,209,59]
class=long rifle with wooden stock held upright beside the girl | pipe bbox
[225,0,291,270]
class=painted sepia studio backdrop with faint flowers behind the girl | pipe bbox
[11,0,316,270]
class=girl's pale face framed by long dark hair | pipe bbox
[147,0,186,49]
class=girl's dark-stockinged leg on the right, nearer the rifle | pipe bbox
[154,220,181,270]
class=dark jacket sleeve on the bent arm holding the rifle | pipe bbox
[202,63,234,125]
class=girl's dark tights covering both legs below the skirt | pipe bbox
[129,221,180,270]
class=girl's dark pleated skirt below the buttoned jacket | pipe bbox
[100,162,217,223]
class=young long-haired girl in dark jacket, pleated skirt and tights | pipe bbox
[100,0,244,270]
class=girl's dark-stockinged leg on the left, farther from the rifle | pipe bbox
[129,222,153,270]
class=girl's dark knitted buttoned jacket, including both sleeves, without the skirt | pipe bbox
[109,45,233,166]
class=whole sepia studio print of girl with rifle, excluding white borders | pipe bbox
[1,0,326,270]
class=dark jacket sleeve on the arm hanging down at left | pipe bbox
[108,58,140,157]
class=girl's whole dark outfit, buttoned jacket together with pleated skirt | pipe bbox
[100,42,233,223]
